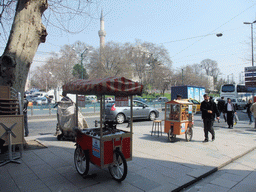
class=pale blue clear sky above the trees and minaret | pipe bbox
[2,0,256,82]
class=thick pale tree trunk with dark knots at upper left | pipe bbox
[0,0,48,95]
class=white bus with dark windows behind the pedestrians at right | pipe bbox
[220,84,253,100]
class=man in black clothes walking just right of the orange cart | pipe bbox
[200,94,220,142]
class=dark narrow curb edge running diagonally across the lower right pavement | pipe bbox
[172,146,256,192]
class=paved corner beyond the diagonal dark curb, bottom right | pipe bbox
[184,150,256,192]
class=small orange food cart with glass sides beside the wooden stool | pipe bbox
[164,100,194,141]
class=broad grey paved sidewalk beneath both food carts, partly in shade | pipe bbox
[0,119,256,192]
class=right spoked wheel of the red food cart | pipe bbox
[108,150,127,182]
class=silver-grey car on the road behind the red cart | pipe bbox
[105,100,159,124]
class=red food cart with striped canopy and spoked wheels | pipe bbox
[63,77,143,181]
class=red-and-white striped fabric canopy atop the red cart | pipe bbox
[63,77,143,96]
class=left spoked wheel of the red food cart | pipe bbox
[74,146,90,176]
